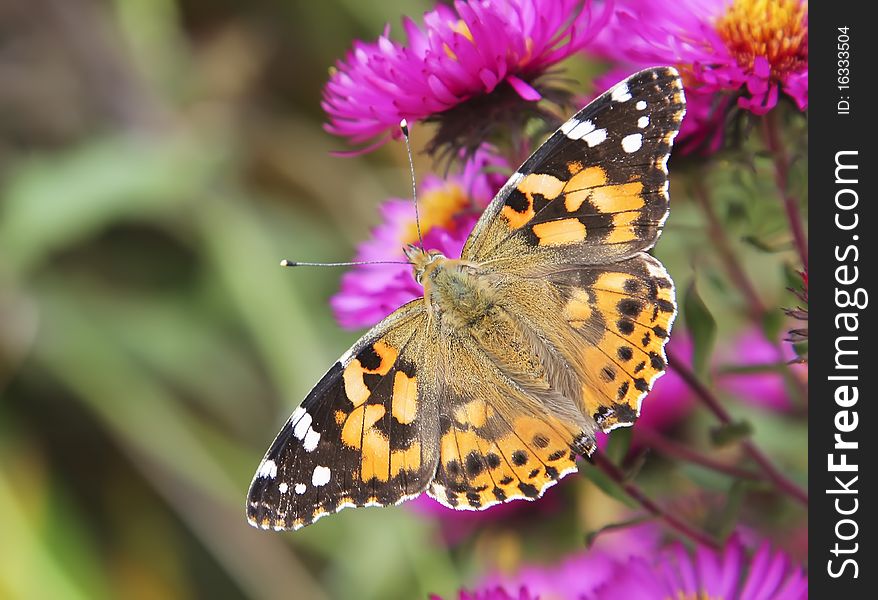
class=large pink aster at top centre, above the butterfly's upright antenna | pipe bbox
[322,0,610,155]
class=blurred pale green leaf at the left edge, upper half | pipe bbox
[0,137,218,270]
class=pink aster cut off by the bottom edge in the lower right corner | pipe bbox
[588,537,808,600]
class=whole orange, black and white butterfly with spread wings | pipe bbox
[247,67,685,530]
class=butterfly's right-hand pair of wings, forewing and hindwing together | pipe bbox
[460,67,685,436]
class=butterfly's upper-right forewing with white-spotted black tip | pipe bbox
[463,67,685,270]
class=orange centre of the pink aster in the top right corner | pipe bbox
[716,0,808,77]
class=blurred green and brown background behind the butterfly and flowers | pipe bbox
[0,0,804,599]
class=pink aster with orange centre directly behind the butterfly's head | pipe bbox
[330,150,509,329]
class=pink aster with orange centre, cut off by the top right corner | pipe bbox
[592,0,808,149]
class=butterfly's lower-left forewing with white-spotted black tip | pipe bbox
[247,300,439,530]
